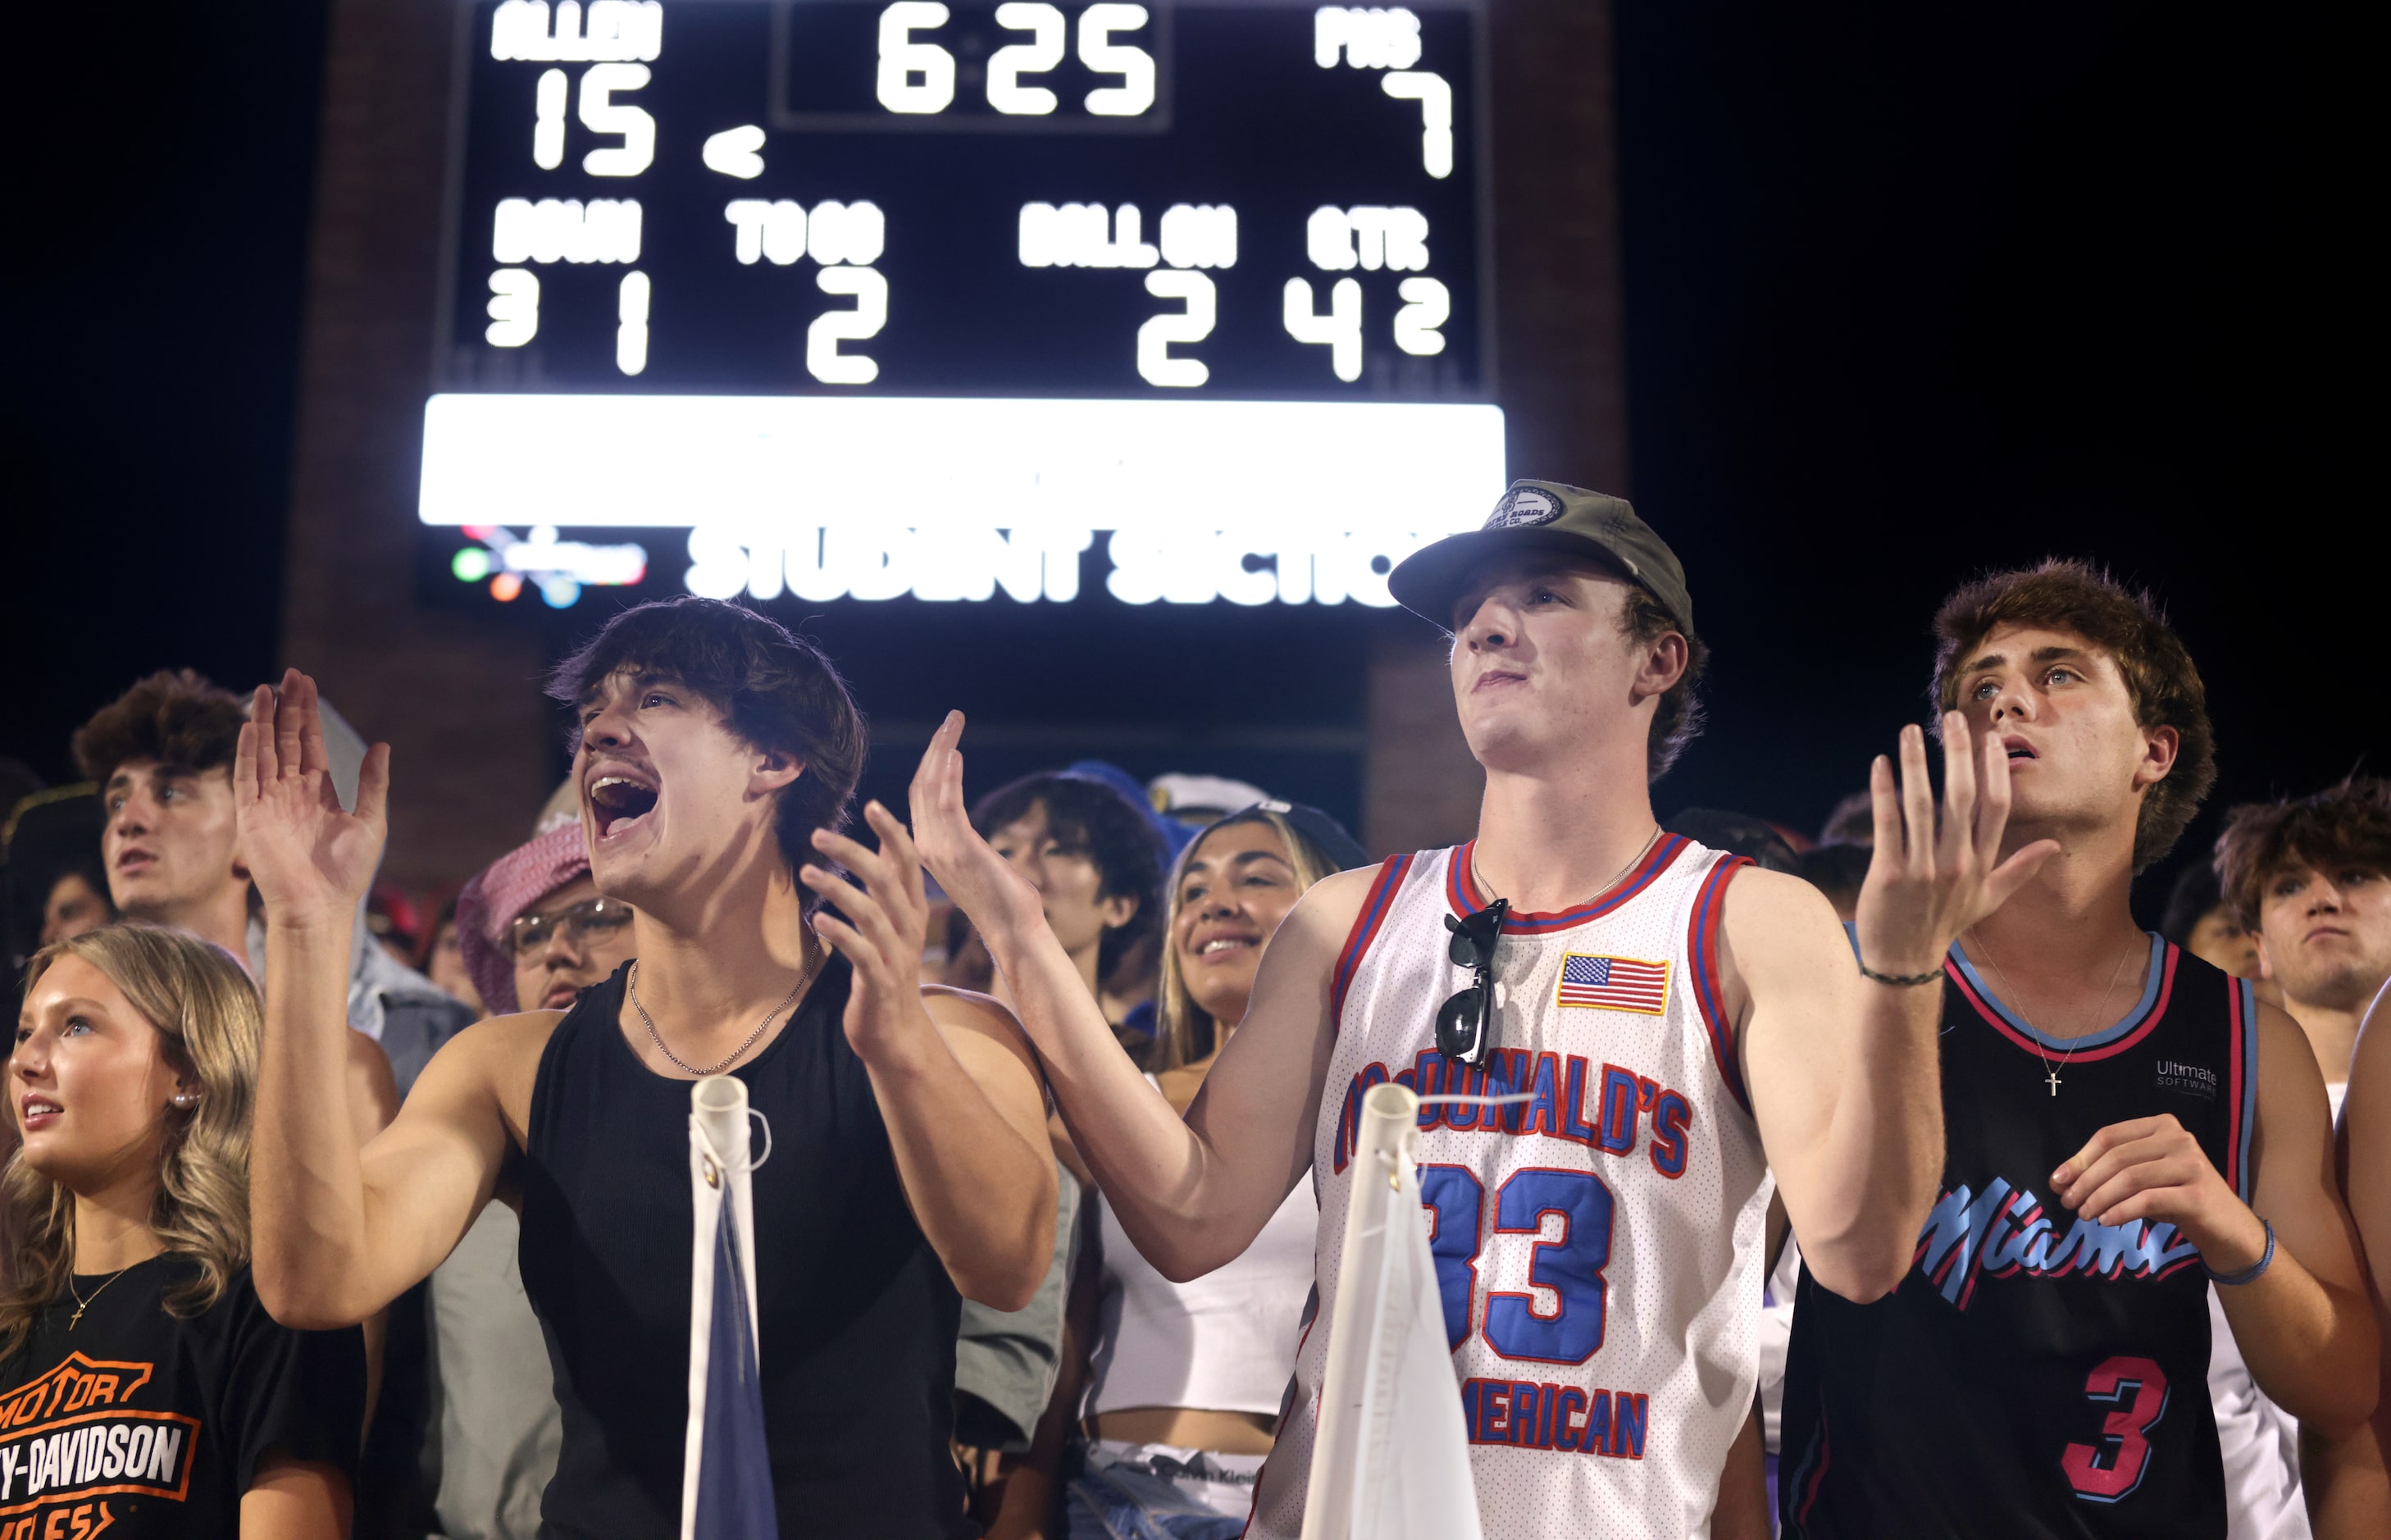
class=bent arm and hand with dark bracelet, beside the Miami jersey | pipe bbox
[1722,713,2059,1303]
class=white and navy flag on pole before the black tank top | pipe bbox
[681,1073,780,1540]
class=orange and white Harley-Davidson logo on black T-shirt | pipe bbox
[0,1354,198,1540]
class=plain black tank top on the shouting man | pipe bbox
[521,955,978,1540]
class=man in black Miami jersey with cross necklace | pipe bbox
[1779,562,2377,1540]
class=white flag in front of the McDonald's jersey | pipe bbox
[1303,1083,1480,1540]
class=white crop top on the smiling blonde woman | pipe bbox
[1086,1076,1320,1415]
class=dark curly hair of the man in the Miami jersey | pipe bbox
[1932,557,2216,870]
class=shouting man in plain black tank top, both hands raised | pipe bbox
[235,598,1054,1540]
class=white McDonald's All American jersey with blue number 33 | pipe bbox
[1246,832,1772,1540]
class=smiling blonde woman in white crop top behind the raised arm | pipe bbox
[990,801,1368,1540]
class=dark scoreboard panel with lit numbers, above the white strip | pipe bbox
[440,0,1490,399]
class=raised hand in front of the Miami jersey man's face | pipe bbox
[1858,710,2059,976]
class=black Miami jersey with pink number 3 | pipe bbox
[1779,937,2257,1540]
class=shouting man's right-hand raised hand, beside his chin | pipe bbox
[796,801,935,1064]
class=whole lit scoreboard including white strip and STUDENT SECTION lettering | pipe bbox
[421,0,1504,605]
